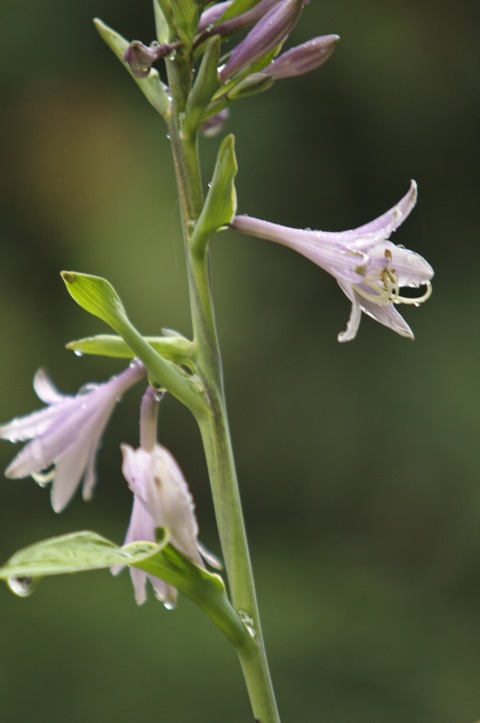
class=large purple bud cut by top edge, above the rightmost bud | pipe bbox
[219,0,305,82]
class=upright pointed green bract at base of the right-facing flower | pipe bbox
[191,135,238,254]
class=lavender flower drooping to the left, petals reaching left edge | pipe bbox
[0,362,145,512]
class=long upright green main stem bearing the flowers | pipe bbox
[167,57,280,723]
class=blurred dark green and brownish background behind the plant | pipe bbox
[0,0,480,723]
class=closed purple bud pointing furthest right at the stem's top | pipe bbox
[262,35,340,80]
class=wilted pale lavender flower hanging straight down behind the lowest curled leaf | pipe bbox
[112,387,215,609]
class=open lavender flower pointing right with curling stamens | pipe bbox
[231,181,433,342]
